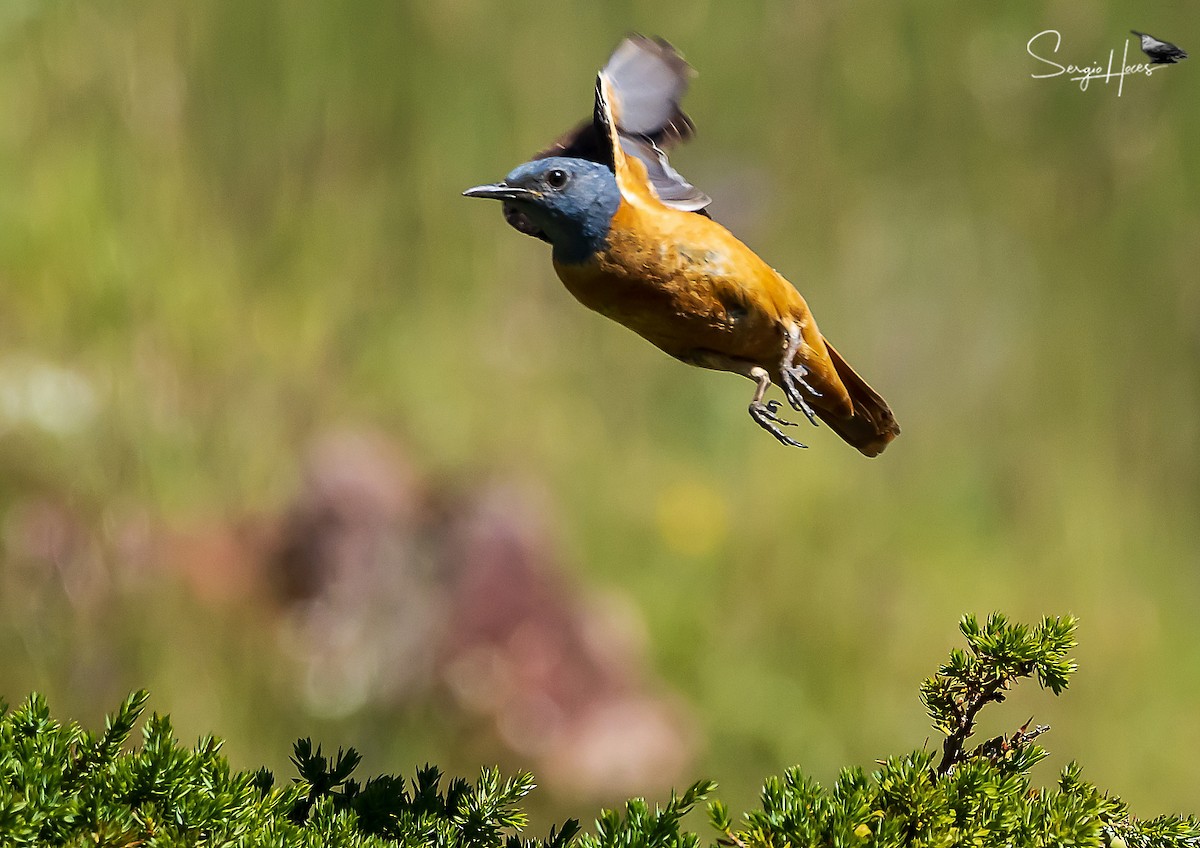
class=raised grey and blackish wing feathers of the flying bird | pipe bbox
[534,35,712,213]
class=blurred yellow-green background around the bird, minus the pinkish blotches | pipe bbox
[0,0,1200,818]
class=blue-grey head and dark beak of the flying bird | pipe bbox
[463,156,620,263]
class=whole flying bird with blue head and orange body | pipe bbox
[463,35,900,457]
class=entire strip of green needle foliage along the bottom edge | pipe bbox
[0,615,1200,848]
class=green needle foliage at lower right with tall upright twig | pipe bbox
[709,614,1200,848]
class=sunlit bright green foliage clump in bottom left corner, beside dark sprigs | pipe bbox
[0,692,298,846]
